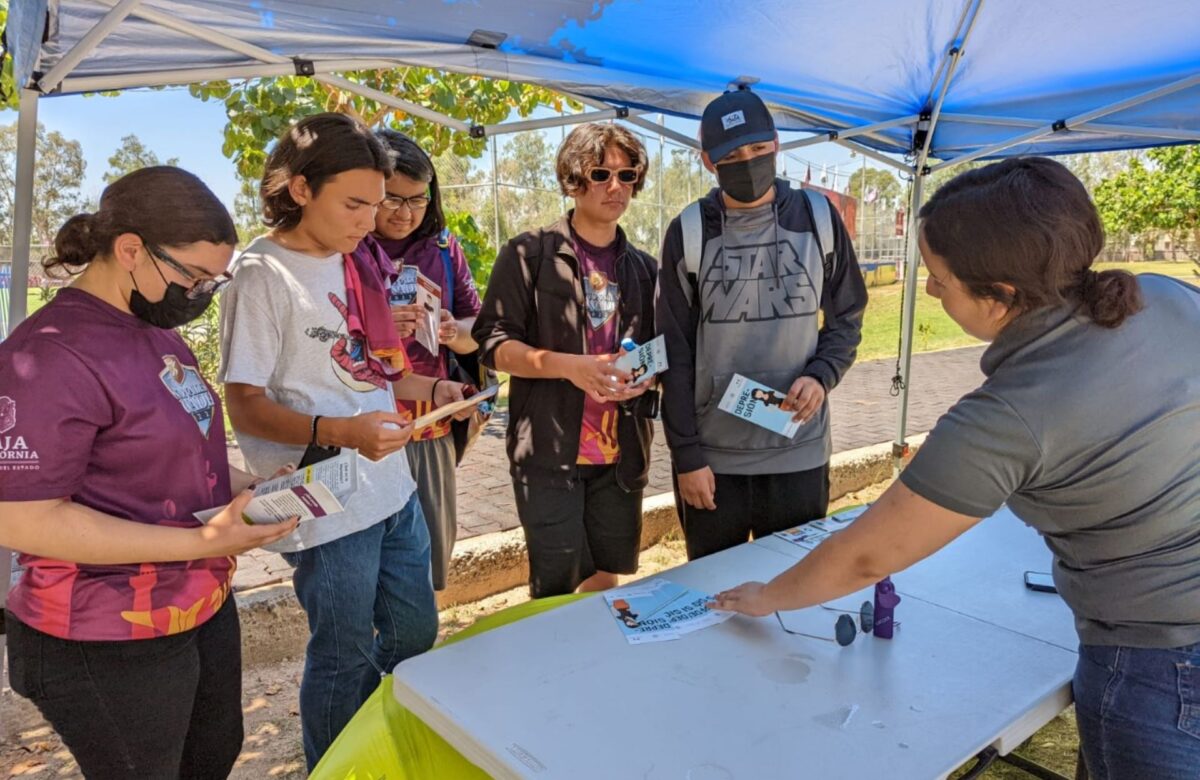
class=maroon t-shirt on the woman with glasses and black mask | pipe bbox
[0,287,235,640]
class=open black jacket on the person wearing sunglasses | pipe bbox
[472,215,658,491]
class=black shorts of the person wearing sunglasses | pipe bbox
[512,466,642,599]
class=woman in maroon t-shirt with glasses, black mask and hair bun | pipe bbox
[0,166,296,779]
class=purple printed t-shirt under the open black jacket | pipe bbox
[571,232,620,466]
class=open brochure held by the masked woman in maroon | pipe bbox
[194,450,359,524]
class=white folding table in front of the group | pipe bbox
[395,506,1076,780]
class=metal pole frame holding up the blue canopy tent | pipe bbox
[0,0,1200,662]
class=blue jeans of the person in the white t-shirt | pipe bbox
[283,493,438,772]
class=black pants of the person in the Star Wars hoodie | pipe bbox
[671,463,829,560]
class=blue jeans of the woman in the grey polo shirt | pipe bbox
[1074,644,1200,780]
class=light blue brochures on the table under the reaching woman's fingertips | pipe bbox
[604,580,732,644]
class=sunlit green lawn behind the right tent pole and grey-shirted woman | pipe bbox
[858,260,1200,360]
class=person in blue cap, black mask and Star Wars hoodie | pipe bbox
[654,89,866,559]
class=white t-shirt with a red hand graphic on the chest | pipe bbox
[218,236,416,552]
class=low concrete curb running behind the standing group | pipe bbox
[238,433,925,666]
